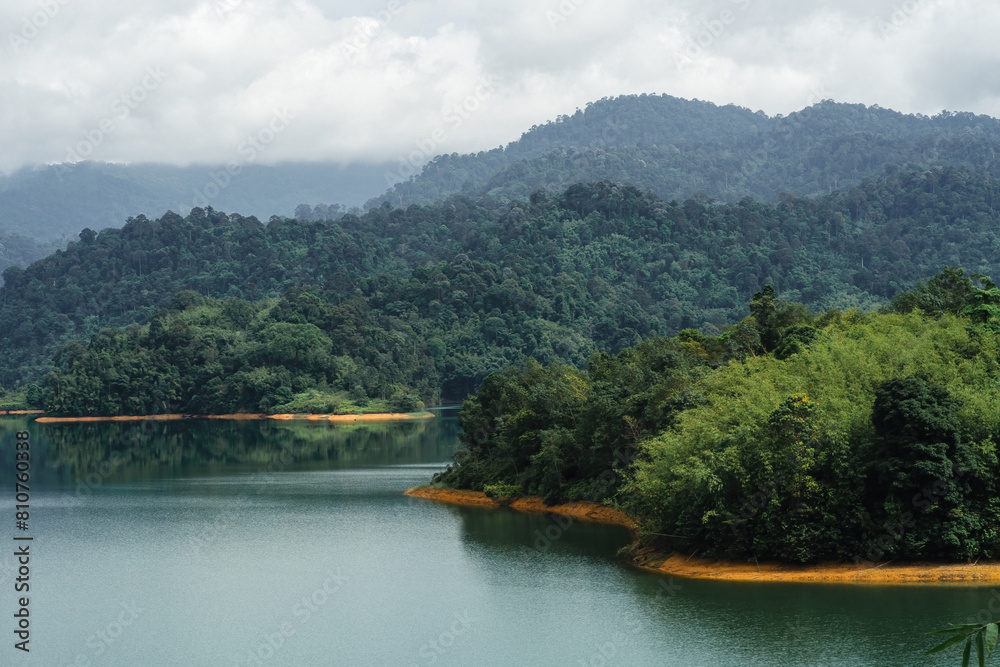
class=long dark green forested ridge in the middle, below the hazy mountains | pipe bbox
[0,169,1000,400]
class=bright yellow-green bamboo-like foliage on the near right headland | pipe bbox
[628,313,1000,561]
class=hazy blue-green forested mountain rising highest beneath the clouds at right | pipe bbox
[369,95,1000,211]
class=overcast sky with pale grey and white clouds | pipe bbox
[0,0,1000,171]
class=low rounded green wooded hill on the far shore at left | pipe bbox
[29,291,440,415]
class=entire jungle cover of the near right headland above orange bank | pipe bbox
[435,269,1000,563]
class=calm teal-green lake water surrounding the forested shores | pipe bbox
[0,411,997,667]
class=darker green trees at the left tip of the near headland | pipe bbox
[435,338,707,502]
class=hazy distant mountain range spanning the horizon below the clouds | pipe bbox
[0,95,1000,272]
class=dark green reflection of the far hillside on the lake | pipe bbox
[0,417,458,485]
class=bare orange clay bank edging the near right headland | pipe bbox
[406,486,1000,586]
